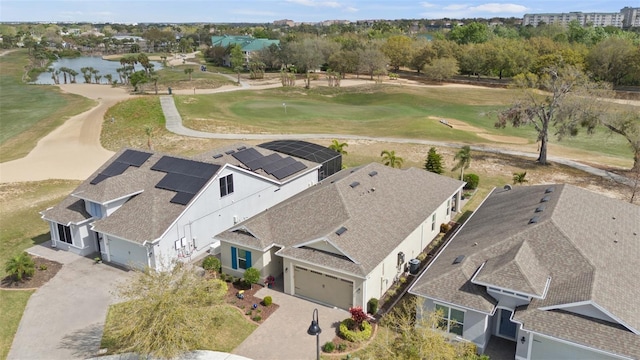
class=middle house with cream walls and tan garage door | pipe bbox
[215,163,464,309]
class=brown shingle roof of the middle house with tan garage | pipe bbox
[216,163,464,276]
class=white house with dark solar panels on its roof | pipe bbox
[41,144,321,269]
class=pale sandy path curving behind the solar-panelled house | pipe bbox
[0,84,131,183]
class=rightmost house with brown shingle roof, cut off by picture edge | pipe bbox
[409,185,640,359]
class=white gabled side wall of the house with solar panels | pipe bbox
[154,166,318,270]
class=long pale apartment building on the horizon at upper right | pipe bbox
[522,7,640,29]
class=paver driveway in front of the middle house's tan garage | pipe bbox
[232,288,351,360]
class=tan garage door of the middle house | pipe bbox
[293,266,353,310]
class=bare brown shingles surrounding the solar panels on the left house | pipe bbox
[42,144,320,243]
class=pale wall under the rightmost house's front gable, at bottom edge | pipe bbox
[530,334,620,360]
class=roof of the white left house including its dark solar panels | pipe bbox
[42,144,320,243]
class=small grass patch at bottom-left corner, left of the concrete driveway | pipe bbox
[0,290,33,360]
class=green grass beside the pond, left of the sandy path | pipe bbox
[0,50,94,162]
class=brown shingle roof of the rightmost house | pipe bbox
[410,185,640,357]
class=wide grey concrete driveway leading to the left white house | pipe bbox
[7,245,132,360]
